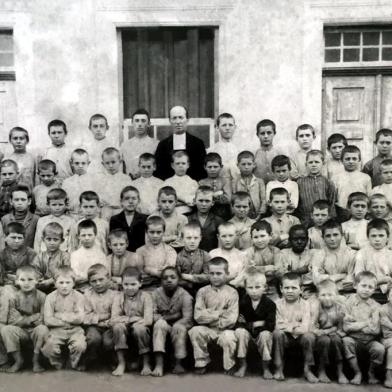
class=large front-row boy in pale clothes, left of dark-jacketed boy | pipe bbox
[189,257,238,374]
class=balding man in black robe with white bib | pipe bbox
[155,106,206,180]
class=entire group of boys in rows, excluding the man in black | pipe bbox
[0,109,392,387]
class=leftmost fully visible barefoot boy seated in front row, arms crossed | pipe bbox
[1,265,49,373]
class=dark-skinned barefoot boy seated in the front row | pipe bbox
[151,267,193,377]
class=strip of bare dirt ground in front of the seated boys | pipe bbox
[0,371,388,392]
